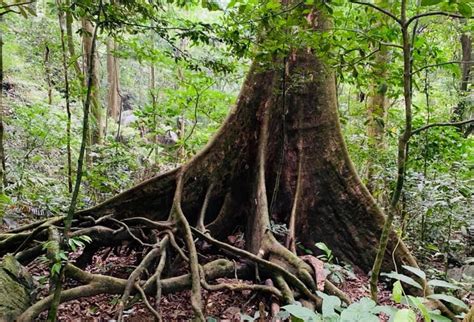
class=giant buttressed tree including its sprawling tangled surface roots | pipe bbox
[0,1,456,320]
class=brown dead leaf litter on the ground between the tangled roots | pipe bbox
[16,235,399,321]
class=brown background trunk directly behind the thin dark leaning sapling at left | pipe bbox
[82,19,104,144]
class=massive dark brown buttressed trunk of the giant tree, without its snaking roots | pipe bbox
[79,51,415,271]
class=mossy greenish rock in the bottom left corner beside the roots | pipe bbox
[0,255,33,321]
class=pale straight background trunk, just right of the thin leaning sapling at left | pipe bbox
[107,38,120,121]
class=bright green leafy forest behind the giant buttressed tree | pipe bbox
[0,0,474,320]
